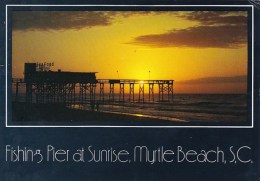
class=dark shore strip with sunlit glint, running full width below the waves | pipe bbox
[9,102,248,126]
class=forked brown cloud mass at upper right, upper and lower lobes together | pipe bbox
[129,11,247,48]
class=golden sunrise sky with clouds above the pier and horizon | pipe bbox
[12,11,248,94]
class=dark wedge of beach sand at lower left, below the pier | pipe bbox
[12,103,175,125]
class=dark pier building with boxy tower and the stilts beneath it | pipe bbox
[24,63,97,104]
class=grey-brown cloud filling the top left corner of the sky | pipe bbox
[12,11,112,31]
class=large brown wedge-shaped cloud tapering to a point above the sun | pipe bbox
[129,25,247,48]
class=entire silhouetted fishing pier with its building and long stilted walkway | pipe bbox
[12,63,174,105]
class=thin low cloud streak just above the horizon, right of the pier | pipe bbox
[178,75,247,84]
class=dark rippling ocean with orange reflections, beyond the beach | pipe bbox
[72,94,248,122]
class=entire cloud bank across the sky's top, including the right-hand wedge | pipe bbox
[12,11,247,48]
